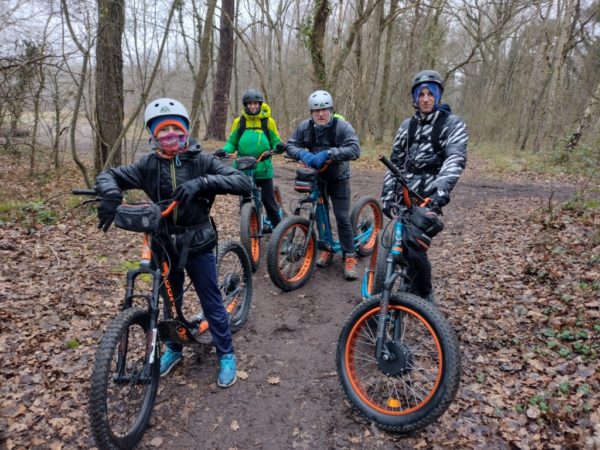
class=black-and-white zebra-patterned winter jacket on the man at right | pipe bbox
[381,111,468,207]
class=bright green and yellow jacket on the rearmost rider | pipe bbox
[223,102,281,180]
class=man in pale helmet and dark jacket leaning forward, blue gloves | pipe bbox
[287,91,360,280]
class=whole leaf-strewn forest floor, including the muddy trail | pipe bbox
[0,151,600,449]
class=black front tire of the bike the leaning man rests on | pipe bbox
[267,216,317,292]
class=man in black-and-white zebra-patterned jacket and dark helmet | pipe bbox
[381,70,468,301]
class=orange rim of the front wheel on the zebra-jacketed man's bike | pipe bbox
[344,305,443,416]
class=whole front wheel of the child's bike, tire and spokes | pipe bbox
[89,308,160,449]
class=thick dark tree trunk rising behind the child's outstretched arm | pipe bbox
[94,0,125,172]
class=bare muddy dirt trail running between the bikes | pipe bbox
[136,165,570,449]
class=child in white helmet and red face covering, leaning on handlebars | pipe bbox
[96,98,251,387]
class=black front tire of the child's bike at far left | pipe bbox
[89,308,160,449]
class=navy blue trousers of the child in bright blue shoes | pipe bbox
[164,252,233,357]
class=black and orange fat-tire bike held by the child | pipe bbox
[73,189,252,449]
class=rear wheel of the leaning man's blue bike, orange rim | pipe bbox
[350,195,383,256]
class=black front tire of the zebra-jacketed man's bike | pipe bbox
[336,292,461,434]
